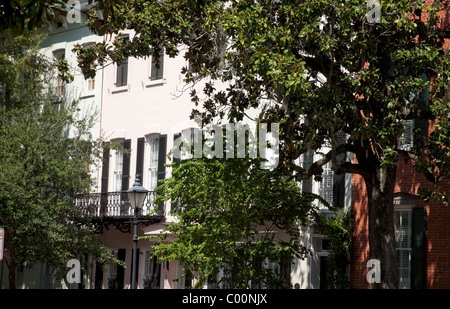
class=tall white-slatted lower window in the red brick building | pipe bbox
[394,209,412,289]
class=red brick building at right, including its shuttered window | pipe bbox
[350,143,450,289]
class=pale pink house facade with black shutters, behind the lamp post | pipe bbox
[83,32,206,289]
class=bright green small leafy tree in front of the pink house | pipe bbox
[150,158,316,288]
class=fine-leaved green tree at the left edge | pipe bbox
[0,33,116,288]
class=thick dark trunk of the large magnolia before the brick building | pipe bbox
[364,164,398,289]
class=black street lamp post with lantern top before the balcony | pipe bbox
[127,175,148,289]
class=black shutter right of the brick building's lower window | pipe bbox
[411,207,426,289]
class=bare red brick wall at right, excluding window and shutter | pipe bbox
[350,154,450,289]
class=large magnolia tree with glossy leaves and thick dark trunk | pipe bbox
[78,0,450,288]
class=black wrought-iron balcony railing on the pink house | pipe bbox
[76,191,164,218]
